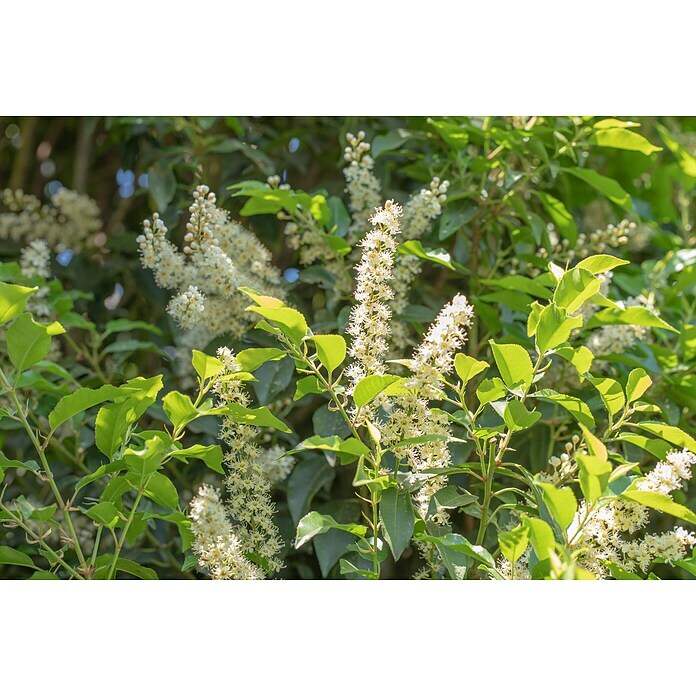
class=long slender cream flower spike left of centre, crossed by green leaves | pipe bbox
[213,348,287,572]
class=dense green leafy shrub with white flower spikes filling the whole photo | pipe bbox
[0,117,696,579]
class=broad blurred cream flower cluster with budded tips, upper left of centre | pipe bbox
[137,186,284,370]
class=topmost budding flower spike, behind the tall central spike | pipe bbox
[343,131,382,246]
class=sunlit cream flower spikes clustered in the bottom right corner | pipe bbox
[568,449,696,577]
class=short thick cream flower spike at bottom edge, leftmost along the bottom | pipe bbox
[189,484,263,580]
